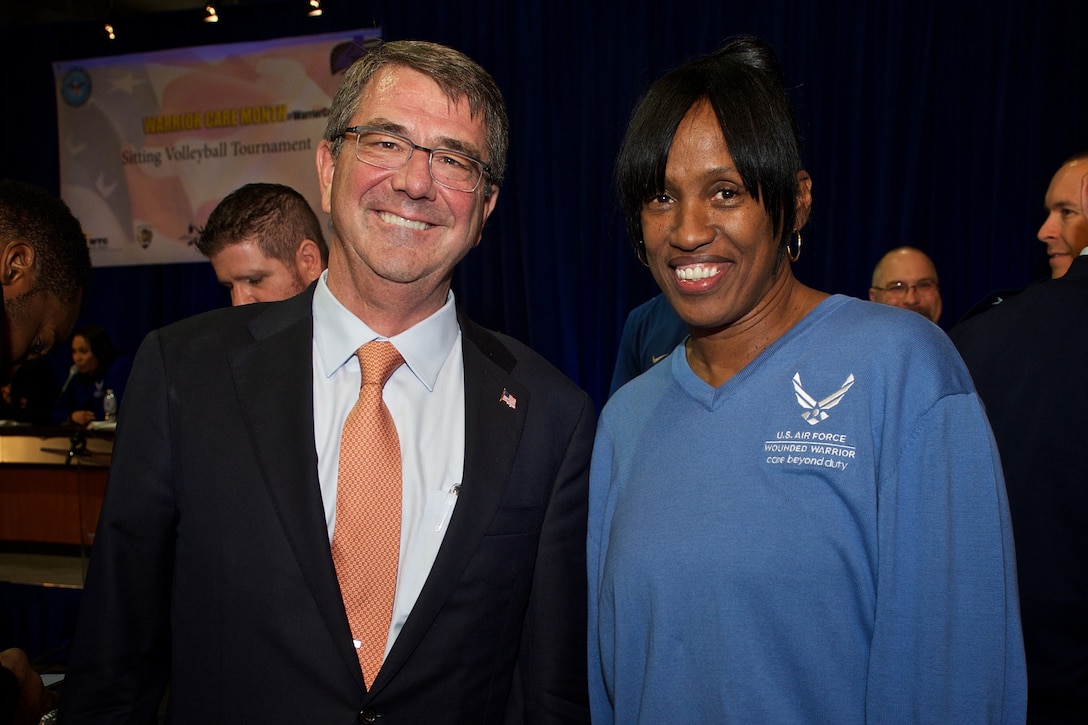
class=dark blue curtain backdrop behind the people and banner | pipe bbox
[0,0,1088,405]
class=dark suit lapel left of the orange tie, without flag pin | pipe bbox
[230,286,363,688]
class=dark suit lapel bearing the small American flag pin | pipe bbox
[373,309,530,691]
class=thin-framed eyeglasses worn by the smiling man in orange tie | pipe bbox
[339,126,491,192]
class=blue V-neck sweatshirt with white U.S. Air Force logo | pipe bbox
[588,296,1026,725]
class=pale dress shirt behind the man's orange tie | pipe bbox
[315,271,465,655]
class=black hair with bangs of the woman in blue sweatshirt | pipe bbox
[616,36,803,258]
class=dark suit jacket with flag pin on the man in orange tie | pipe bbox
[61,287,595,725]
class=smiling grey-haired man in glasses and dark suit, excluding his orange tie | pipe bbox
[61,41,595,725]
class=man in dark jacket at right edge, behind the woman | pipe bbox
[949,156,1088,723]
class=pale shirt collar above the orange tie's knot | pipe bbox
[313,270,460,391]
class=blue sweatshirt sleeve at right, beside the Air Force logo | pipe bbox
[866,394,1026,723]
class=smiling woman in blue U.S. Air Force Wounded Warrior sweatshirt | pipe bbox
[588,37,1026,725]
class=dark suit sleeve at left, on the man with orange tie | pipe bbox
[61,333,176,723]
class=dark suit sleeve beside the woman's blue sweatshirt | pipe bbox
[507,395,596,724]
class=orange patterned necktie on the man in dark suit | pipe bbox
[332,340,404,690]
